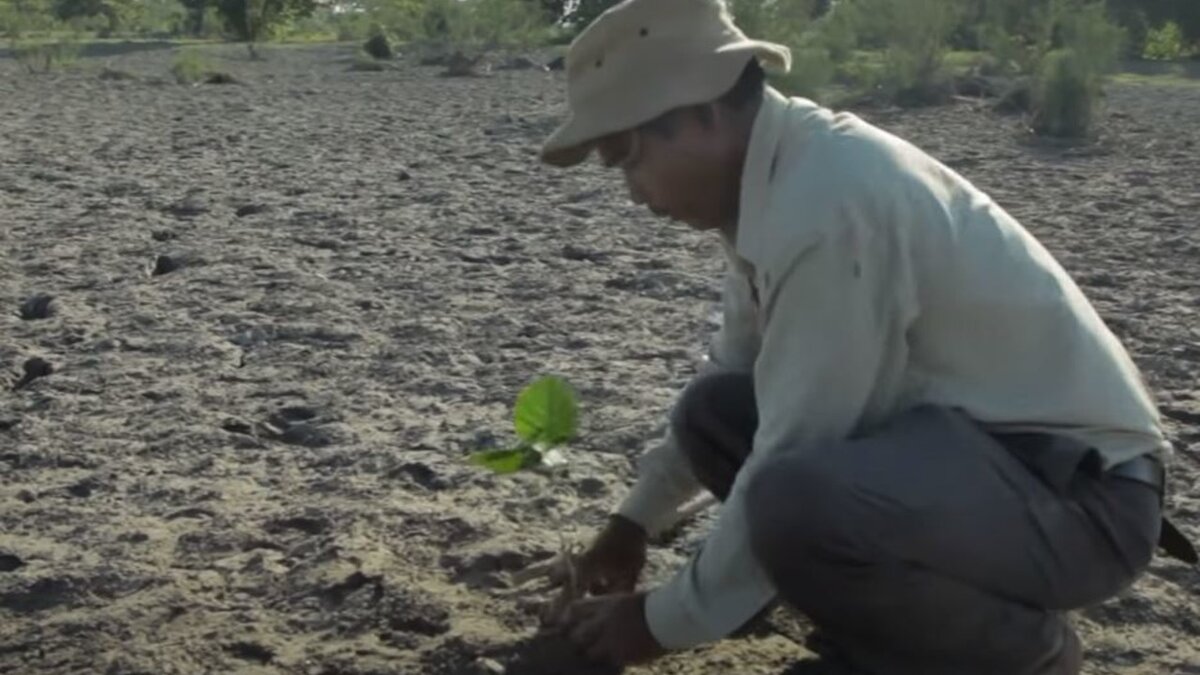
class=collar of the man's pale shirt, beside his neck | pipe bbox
[732,86,791,263]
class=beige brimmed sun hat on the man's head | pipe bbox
[541,0,792,167]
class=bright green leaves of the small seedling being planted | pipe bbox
[469,375,580,474]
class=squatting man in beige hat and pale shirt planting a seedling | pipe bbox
[532,0,1190,675]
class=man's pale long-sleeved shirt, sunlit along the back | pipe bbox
[618,88,1170,649]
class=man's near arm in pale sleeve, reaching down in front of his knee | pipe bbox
[646,209,906,649]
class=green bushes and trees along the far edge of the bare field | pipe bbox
[0,0,1200,137]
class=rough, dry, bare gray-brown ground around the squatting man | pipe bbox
[0,42,1200,675]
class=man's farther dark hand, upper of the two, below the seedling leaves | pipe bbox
[551,515,647,596]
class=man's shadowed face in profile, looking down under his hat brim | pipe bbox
[598,112,740,229]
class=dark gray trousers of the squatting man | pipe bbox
[673,375,1162,675]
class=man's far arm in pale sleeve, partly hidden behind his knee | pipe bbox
[617,247,758,536]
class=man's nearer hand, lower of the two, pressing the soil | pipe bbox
[552,593,666,665]
